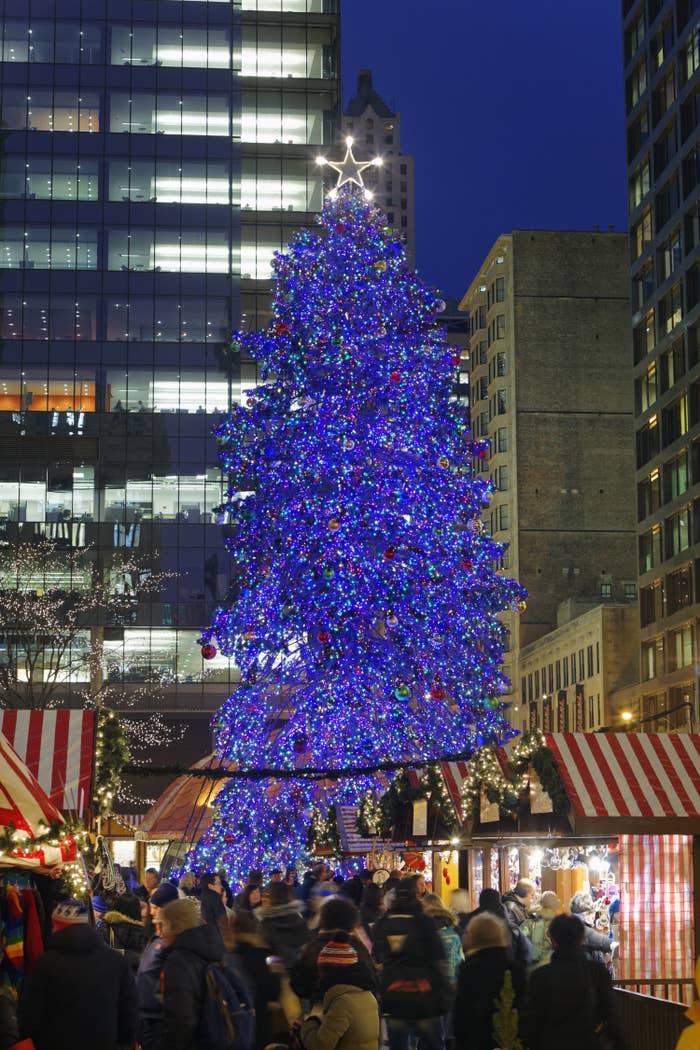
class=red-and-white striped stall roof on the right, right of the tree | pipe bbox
[545,733,700,819]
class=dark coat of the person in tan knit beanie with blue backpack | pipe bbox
[162,926,224,1050]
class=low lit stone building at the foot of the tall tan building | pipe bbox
[518,601,639,733]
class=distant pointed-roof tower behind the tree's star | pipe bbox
[342,69,416,267]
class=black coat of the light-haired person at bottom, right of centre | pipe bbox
[454,948,525,1050]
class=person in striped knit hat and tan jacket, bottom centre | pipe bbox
[301,938,379,1050]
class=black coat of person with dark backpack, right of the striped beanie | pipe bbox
[373,910,451,1020]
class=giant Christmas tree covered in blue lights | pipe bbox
[197,149,523,876]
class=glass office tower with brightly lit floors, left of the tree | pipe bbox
[0,0,340,781]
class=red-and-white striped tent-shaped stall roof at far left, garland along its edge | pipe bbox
[0,735,77,870]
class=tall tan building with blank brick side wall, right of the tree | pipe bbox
[460,230,636,727]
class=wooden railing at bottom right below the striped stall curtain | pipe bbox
[615,979,695,1050]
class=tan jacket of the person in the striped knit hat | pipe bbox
[301,984,379,1050]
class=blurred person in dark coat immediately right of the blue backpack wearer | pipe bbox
[223,911,287,1050]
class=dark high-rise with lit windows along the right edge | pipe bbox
[622,0,700,728]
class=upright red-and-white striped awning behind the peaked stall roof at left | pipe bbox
[0,710,96,813]
